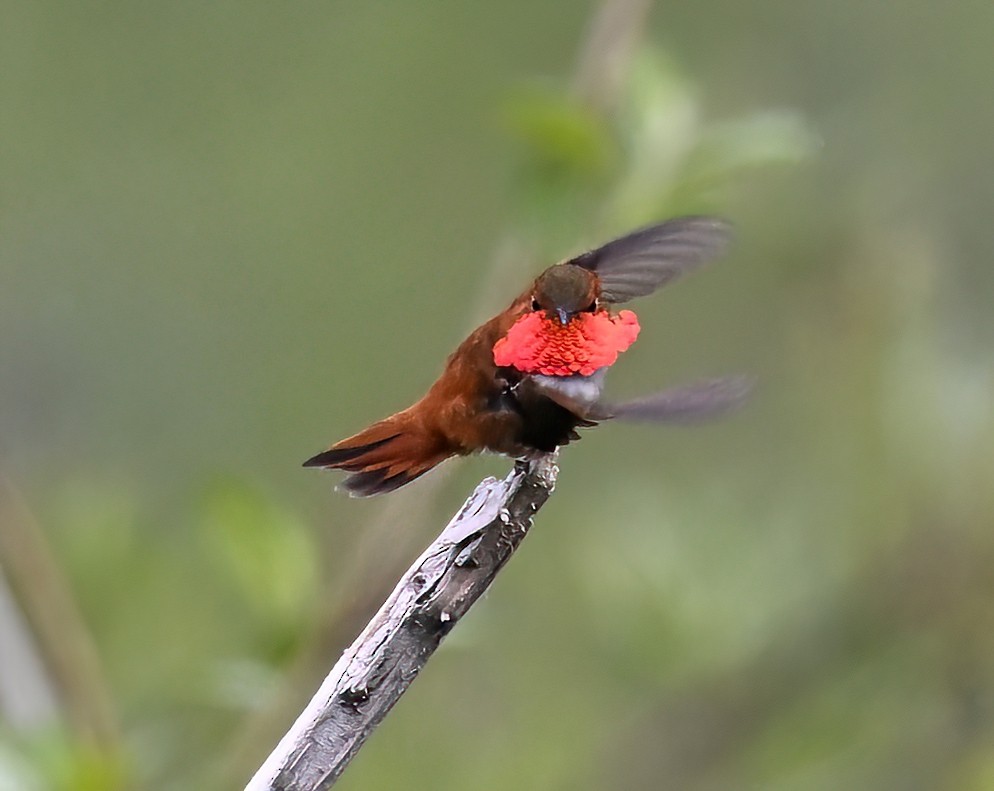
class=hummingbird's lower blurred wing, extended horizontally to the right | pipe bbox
[532,376,753,423]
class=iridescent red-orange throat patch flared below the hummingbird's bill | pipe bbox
[494,310,639,376]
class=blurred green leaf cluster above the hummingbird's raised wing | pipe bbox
[507,49,819,247]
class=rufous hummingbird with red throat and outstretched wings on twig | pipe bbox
[304,216,748,497]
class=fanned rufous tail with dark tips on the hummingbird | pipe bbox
[304,412,452,497]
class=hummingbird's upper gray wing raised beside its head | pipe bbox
[567,216,732,303]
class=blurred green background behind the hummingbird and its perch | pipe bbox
[0,0,994,791]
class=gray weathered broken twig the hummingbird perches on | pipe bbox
[246,454,558,791]
